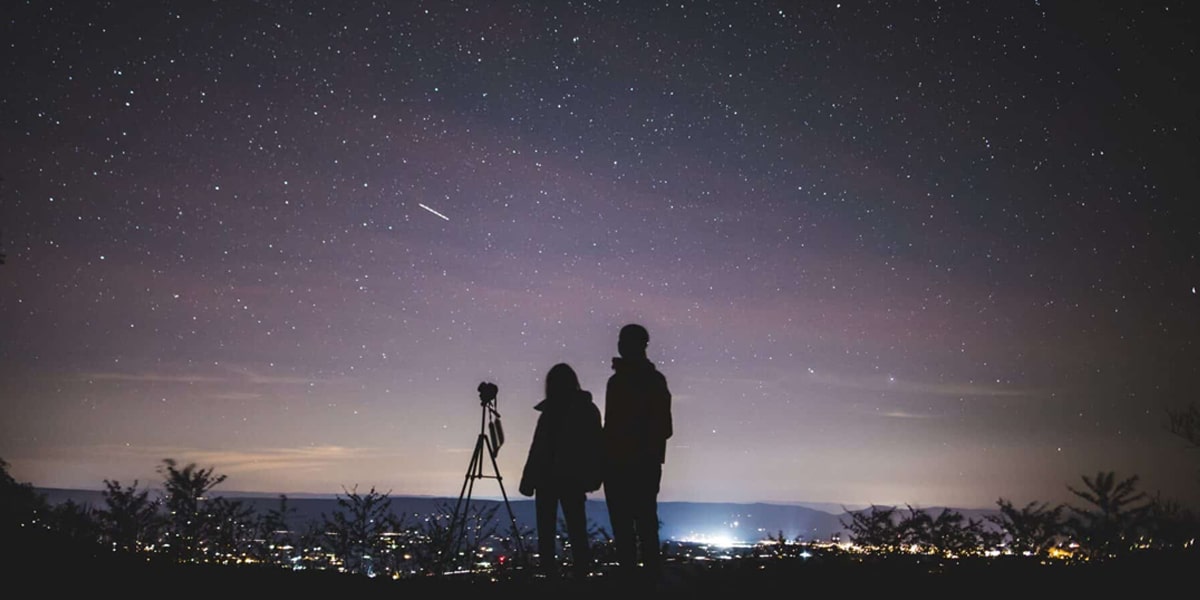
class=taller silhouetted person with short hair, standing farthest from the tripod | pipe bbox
[604,324,672,578]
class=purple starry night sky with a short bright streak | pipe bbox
[0,0,1200,508]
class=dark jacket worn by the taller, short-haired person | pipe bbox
[604,356,673,469]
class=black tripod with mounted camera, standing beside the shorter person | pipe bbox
[449,382,524,568]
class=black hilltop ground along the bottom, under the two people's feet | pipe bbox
[32,554,1198,600]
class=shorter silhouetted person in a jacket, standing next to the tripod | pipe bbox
[520,362,604,577]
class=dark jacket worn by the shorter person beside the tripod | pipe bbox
[520,390,604,496]
